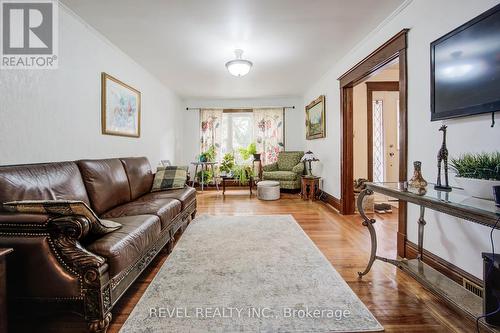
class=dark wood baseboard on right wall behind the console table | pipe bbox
[405,240,484,287]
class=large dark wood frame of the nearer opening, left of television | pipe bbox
[339,29,408,257]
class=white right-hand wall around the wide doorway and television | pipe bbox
[304,0,500,277]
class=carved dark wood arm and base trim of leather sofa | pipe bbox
[0,201,196,332]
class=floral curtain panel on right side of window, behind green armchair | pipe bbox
[253,108,285,165]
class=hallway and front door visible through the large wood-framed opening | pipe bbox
[353,61,400,202]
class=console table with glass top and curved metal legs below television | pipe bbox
[357,182,500,332]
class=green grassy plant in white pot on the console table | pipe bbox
[450,152,500,200]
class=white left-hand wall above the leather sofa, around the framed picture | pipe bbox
[0,5,181,166]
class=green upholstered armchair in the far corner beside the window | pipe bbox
[262,151,304,190]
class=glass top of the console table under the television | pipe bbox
[366,182,500,218]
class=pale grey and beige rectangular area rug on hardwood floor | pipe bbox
[120,215,383,333]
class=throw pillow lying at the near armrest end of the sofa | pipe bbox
[3,200,122,235]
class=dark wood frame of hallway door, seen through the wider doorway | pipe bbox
[366,81,399,181]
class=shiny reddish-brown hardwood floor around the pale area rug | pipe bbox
[108,189,474,333]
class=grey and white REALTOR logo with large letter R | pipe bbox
[0,0,58,69]
